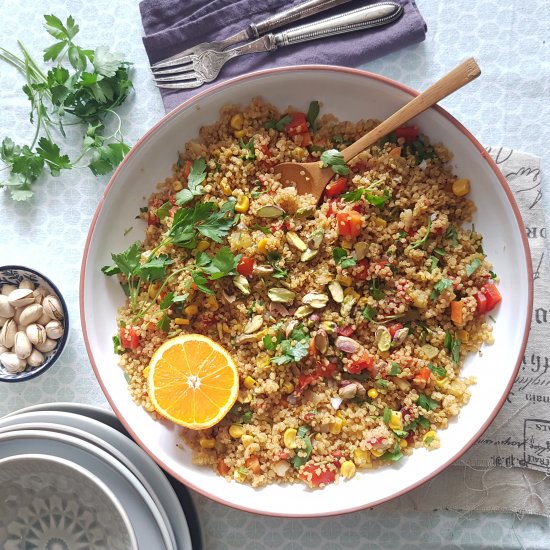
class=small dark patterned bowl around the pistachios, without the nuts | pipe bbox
[0,265,69,382]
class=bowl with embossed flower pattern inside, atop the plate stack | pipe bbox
[0,454,138,550]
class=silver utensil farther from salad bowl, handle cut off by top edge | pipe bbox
[151,0,358,69]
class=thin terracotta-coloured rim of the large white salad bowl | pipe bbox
[80,65,533,518]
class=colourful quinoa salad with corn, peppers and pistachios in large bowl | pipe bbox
[103,98,501,488]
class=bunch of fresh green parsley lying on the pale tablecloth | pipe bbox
[0,15,132,201]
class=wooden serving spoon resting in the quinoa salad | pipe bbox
[274,57,481,201]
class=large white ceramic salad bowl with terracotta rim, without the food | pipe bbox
[80,66,532,517]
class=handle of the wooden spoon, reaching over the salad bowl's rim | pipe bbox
[342,57,481,162]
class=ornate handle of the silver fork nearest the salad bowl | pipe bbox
[274,2,403,47]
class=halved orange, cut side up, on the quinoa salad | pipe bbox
[147,334,239,430]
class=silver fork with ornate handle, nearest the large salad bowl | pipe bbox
[153,2,403,89]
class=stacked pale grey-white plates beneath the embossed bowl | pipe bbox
[0,403,198,550]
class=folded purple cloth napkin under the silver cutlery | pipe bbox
[139,0,426,112]
